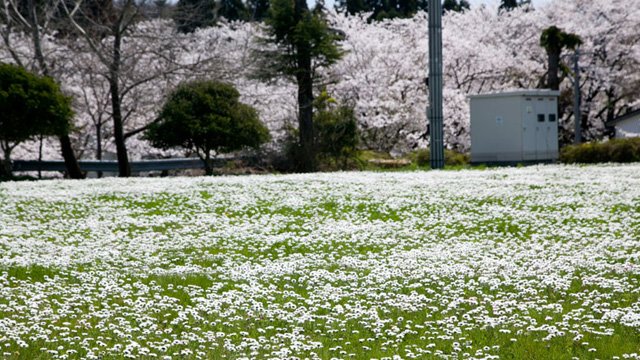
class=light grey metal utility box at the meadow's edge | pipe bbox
[469,89,560,163]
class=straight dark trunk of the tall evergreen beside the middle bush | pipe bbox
[295,0,316,172]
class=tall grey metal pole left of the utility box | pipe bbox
[429,0,444,169]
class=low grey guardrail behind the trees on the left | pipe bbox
[12,158,231,172]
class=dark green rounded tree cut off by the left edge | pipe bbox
[0,64,73,178]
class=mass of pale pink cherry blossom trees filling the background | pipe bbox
[0,0,640,165]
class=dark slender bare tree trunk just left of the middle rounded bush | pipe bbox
[109,25,131,177]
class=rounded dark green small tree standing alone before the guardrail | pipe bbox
[145,81,270,175]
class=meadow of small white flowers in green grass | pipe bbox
[0,165,640,359]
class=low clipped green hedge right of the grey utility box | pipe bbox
[560,138,640,164]
